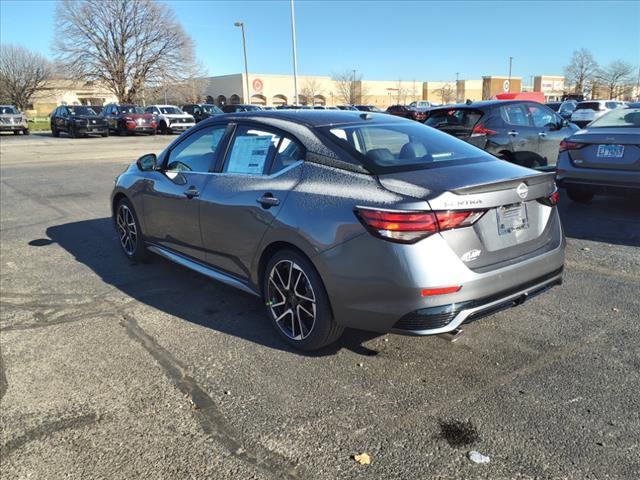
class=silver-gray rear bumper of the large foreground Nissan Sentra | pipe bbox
[313,217,565,335]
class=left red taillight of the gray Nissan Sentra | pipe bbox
[355,208,485,243]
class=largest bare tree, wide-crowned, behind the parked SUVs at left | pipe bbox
[54,0,194,102]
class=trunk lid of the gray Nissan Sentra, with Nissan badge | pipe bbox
[379,160,561,271]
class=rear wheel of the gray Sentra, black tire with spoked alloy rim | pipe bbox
[262,250,344,351]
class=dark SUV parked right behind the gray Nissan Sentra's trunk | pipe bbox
[424,100,578,170]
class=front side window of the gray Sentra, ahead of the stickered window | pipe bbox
[166,125,226,173]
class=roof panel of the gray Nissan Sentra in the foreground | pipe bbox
[210,110,408,127]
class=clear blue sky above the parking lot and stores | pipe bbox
[0,0,640,84]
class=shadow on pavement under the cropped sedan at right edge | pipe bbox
[559,190,640,247]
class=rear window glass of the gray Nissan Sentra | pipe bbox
[321,122,493,173]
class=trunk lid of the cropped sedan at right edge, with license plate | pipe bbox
[567,127,640,171]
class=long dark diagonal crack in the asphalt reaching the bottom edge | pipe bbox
[120,314,302,479]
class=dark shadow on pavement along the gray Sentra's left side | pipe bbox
[46,218,380,356]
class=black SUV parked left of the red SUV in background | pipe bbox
[50,105,109,137]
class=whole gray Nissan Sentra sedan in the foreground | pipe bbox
[112,110,565,350]
